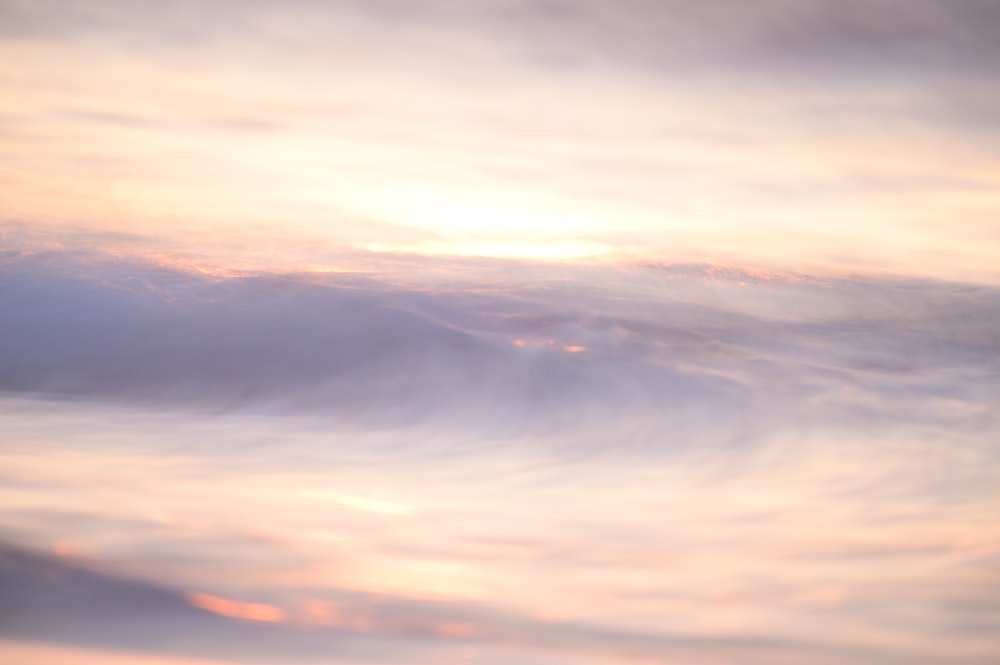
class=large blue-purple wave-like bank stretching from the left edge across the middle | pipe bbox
[0,249,742,440]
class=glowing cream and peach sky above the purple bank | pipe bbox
[0,0,1000,283]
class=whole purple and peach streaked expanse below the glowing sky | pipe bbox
[0,245,1000,664]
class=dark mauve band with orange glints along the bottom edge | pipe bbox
[0,544,932,663]
